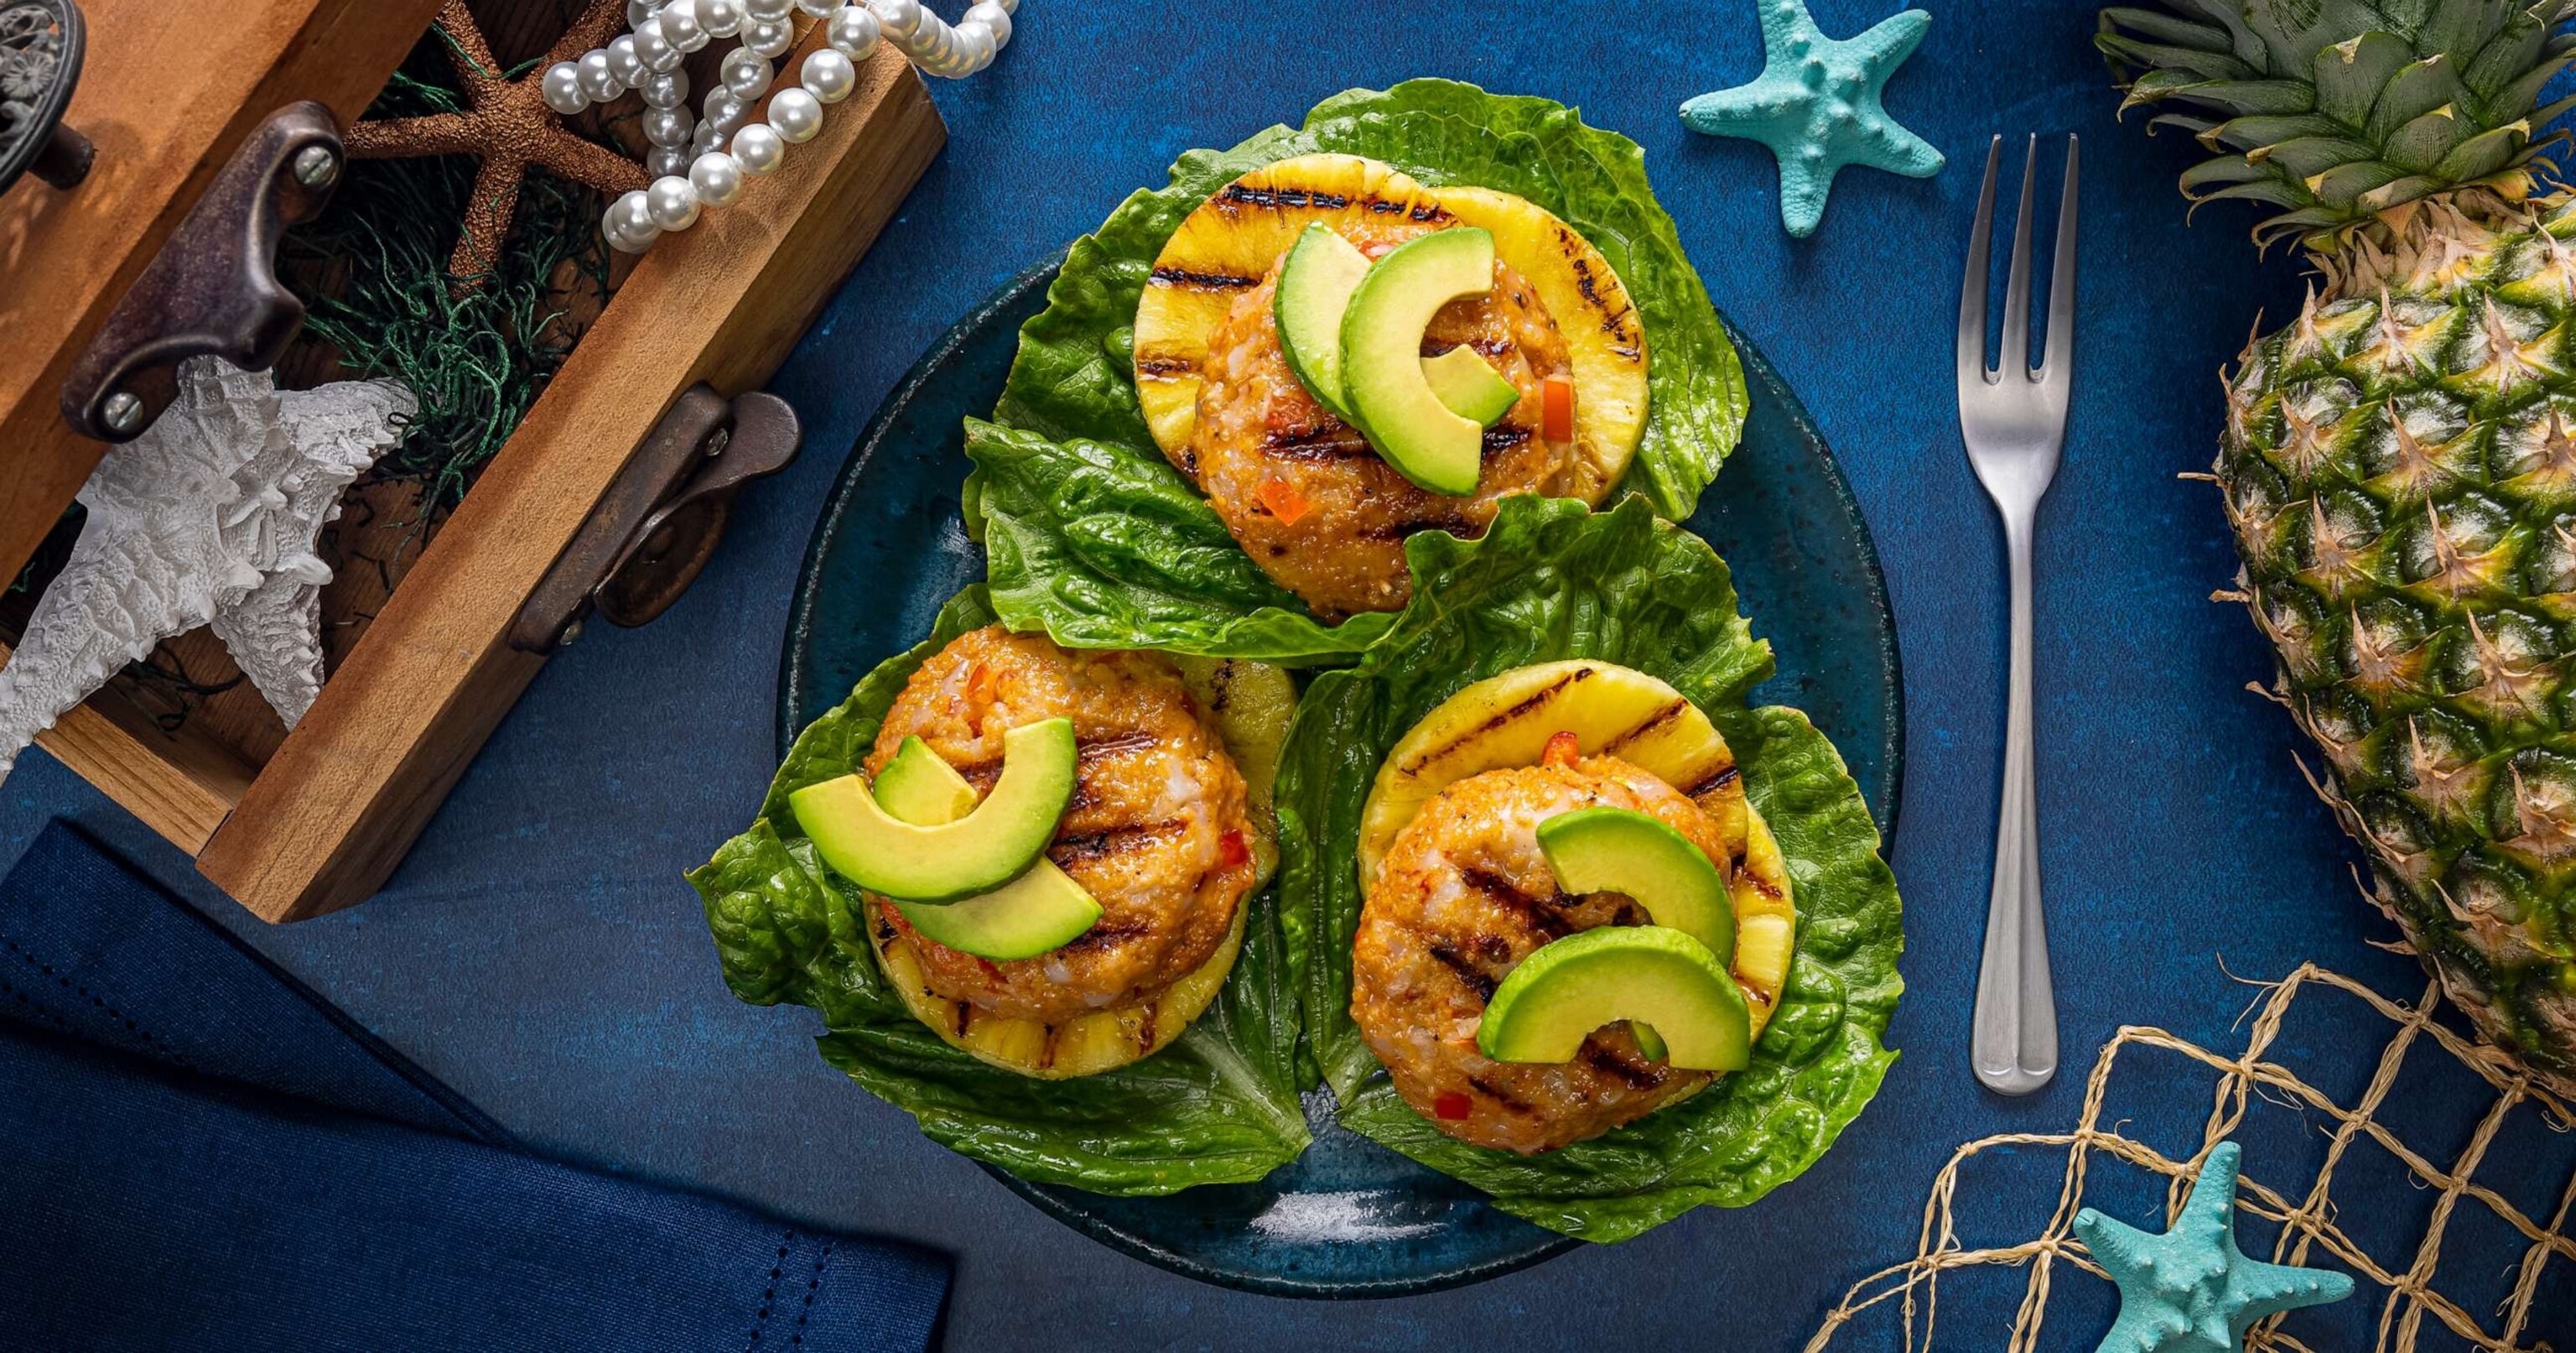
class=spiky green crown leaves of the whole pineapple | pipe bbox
[2095,0,2576,252]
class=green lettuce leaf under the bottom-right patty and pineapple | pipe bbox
[1278,497,1903,1240]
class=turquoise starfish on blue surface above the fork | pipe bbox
[1682,0,1942,240]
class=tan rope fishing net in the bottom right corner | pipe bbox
[1805,964,2576,1353]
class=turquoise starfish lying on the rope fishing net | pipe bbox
[2076,1142,2352,1353]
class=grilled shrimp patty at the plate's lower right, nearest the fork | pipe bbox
[1350,757,1726,1154]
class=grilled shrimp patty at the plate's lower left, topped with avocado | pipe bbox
[868,627,1254,1023]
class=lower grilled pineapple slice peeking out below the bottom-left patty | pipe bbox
[868,897,1252,1080]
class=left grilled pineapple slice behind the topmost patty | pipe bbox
[1136,154,1452,456]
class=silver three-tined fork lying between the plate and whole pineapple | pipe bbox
[1958,137,2076,1095]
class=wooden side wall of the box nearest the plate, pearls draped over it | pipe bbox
[199,49,945,920]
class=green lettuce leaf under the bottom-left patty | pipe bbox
[688,588,1306,1194]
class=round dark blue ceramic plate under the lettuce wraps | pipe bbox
[778,263,1903,1296]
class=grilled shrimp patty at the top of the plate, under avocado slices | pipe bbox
[1172,219,1574,618]
